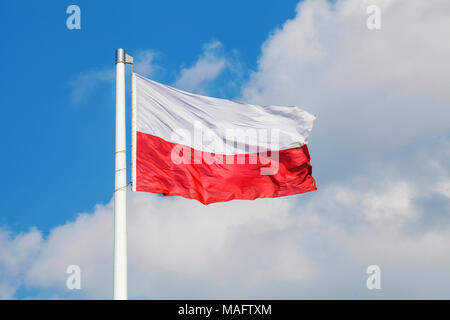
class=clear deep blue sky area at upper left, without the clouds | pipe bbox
[0,1,302,232]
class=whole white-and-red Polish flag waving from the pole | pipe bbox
[132,73,317,204]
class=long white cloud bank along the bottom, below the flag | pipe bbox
[0,169,450,299]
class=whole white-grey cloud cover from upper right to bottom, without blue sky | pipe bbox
[0,0,450,299]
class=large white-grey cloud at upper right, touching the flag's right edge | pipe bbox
[243,0,450,178]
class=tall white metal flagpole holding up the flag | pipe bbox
[114,49,133,300]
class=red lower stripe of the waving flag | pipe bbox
[136,132,317,204]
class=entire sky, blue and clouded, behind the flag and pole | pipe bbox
[0,0,450,299]
